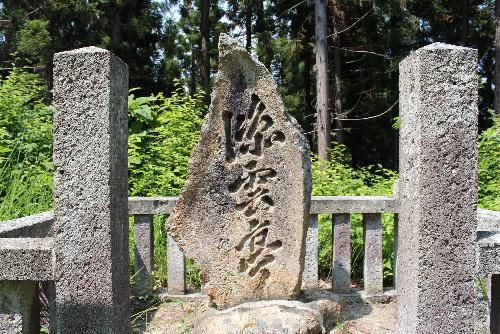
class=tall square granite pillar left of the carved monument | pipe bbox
[54,47,131,334]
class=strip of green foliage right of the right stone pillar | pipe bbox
[478,116,500,211]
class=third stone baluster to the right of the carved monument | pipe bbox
[363,213,384,294]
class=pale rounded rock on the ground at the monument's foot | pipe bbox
[194,300,323,334]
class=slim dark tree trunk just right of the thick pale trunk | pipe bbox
[332,1,345,144]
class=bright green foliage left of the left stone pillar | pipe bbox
[0,68,53,220]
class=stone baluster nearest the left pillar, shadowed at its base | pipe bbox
[134,215,154,295]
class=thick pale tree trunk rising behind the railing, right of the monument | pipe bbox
[315,0,331,160]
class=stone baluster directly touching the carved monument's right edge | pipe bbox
[302,214,318,289]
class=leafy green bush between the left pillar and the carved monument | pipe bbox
[129,83,204,286]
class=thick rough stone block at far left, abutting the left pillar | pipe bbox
[0,238,55,281]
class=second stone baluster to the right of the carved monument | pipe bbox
[333,213,351,293]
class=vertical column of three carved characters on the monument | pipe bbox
[226,94,285,280]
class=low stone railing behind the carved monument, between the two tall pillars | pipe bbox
[129,196,398,294]
